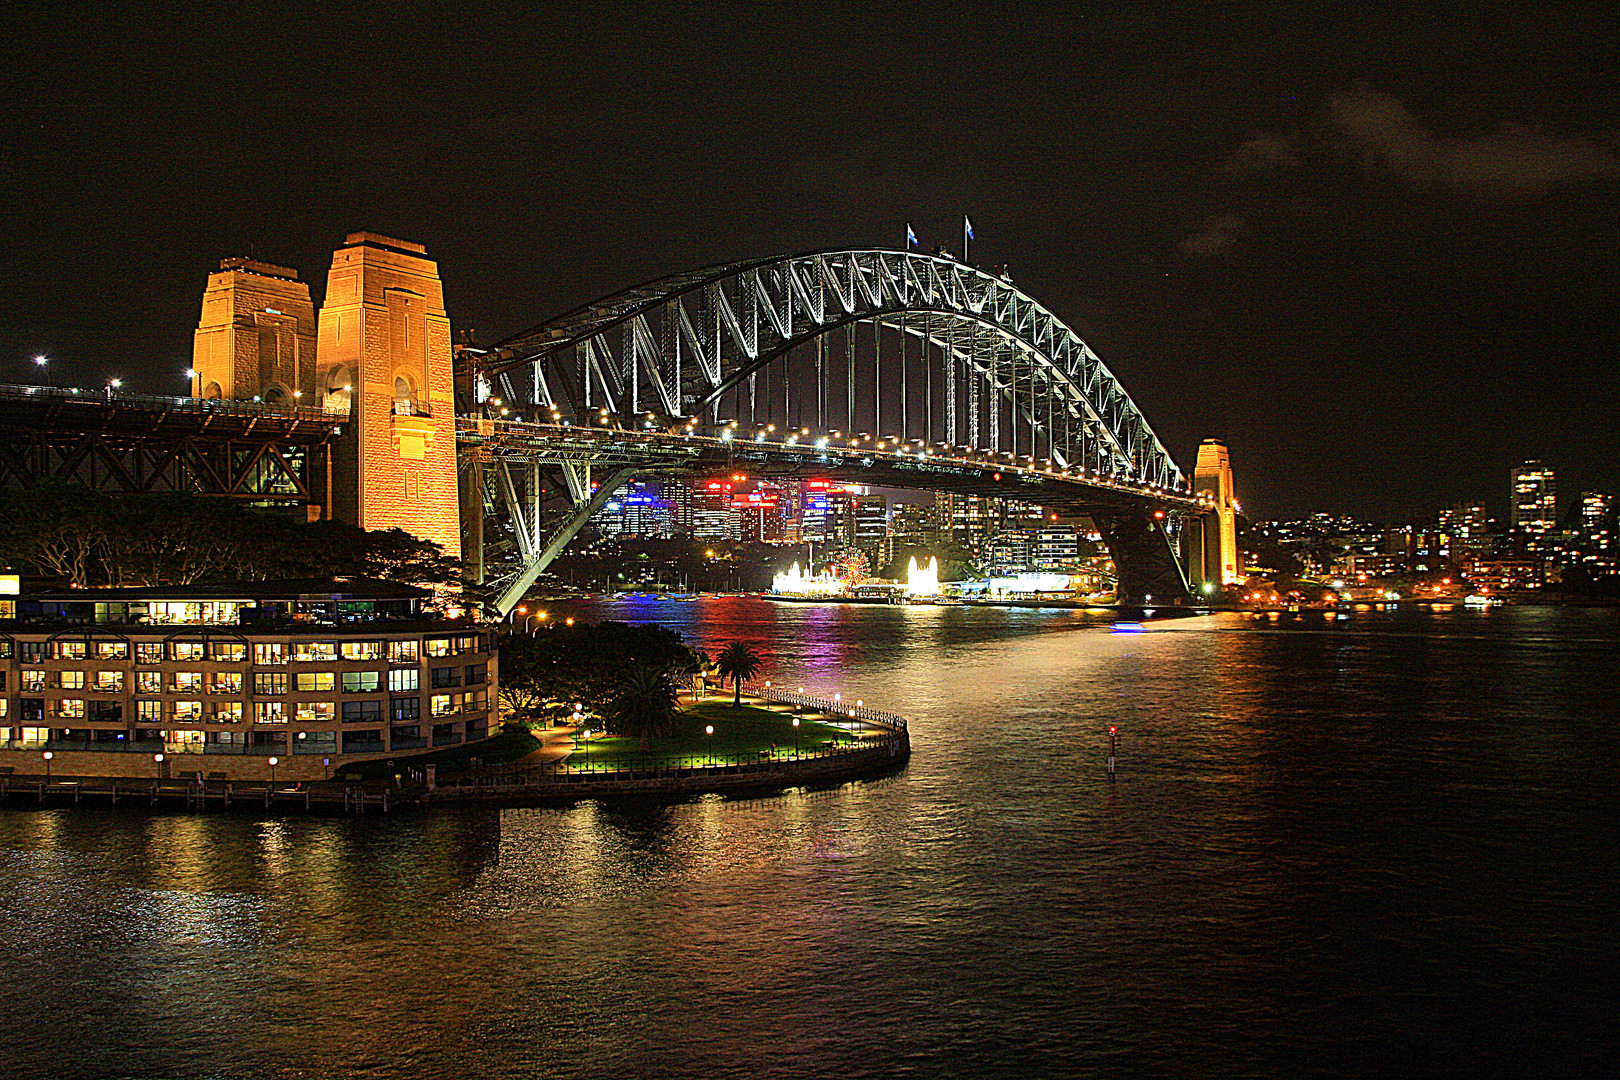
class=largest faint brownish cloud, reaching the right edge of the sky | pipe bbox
[1330,86,1620,201]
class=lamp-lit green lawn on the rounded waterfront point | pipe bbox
[569,701,851,769]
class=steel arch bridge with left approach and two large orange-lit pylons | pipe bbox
[0,233,1220,614]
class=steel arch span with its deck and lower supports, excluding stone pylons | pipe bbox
[458,249,1194,610]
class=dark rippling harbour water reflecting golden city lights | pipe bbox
[0,599,1620,1078]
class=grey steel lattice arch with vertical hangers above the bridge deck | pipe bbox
[463,249,1187,491]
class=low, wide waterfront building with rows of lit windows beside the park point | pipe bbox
[0,578,499,779]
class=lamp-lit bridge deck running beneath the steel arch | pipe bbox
[455,418,1210,517]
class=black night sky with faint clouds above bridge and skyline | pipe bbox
[0,0,1620,517]
